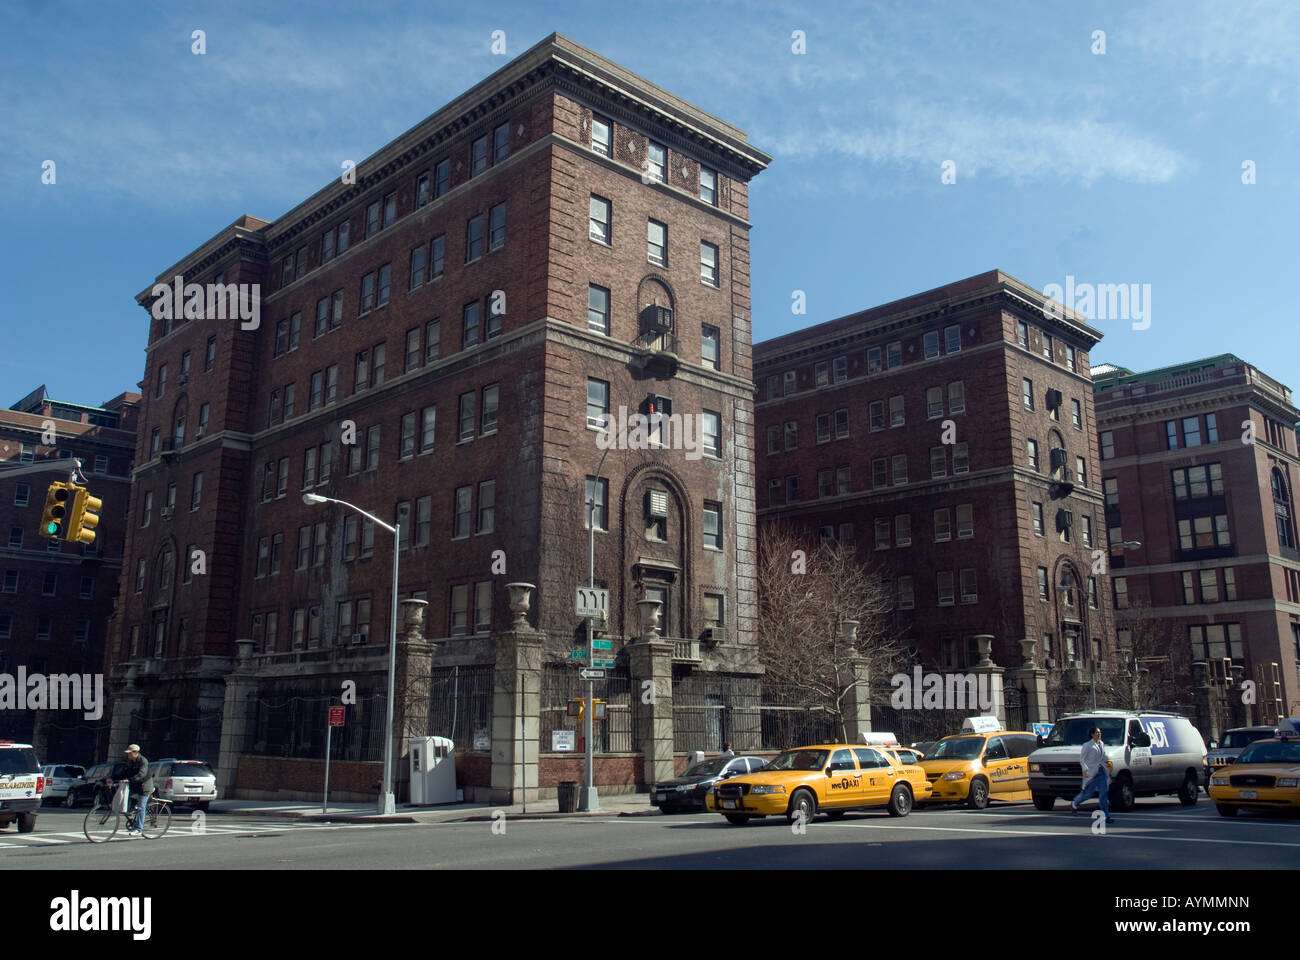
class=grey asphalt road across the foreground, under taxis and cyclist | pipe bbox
[10,797,1300,870]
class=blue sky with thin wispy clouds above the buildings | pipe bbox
[0,0,1300,405]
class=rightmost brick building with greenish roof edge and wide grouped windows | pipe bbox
[1093,354,1300,731]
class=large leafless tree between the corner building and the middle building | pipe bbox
[758,523,902,739]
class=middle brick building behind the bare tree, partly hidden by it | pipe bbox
[754,271,1117,723]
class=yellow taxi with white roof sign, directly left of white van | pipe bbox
[920,717,1039,810]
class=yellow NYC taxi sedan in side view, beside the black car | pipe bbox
[705,743,930,825]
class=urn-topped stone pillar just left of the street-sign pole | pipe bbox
[489,607,546,804]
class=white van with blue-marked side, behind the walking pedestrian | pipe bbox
[1030,710,1205,812]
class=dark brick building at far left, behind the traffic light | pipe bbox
[0,386,140,764]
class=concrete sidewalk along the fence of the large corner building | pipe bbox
[208,793,660,823]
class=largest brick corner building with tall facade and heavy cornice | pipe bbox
[113,35,768,796]
